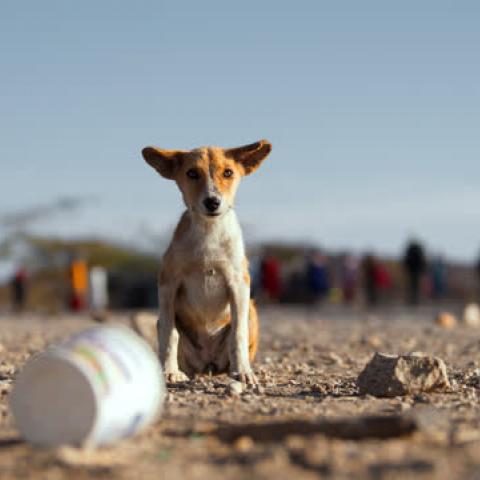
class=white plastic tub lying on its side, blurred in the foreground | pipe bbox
[10,326,166,447]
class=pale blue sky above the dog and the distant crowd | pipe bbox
[0,0,480,261]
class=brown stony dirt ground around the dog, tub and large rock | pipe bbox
[0,307,480,480]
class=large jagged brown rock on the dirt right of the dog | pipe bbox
[357,352,450,397]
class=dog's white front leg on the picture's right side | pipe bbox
[227,275,257,384]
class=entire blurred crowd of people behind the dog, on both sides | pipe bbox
[5,240,480,311]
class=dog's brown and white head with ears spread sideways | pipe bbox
[142,140,272,218]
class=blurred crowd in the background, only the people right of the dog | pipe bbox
[251,239,480,307]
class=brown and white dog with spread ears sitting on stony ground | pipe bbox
[142,140,272,384]
